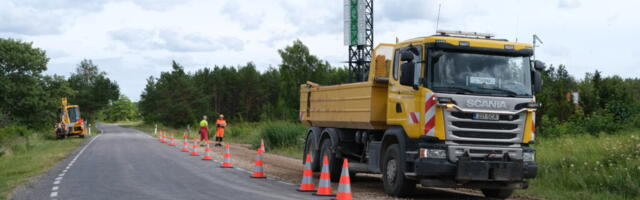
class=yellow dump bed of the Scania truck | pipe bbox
[300,81,387,129]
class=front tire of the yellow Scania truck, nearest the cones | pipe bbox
[382,144,416,197]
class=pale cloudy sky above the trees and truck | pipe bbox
[0,0,640,101]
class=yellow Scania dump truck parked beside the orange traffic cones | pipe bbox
[300,31,544,198]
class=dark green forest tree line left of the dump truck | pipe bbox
[139,40,348,127]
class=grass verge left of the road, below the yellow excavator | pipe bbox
[0,128,87,199]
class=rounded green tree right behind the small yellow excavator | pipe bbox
[69,59,120,121]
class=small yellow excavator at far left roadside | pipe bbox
[55,98,87,139]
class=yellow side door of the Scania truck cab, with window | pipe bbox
[387,45,424,135]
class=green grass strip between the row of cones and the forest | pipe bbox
[123,121,307,159]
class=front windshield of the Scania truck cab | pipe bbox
[429,51,532,97]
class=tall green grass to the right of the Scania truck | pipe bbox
[517,130,640,199]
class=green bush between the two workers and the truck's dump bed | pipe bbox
[254,121,307,148]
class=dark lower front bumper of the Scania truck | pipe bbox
[412,158,538,182]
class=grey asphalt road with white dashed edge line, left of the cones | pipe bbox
[12,125,328,200]
